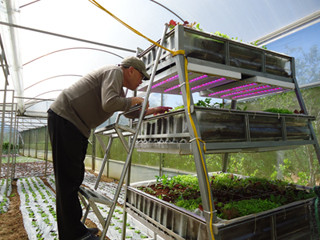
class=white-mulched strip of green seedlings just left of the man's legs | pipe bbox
[17,177,58,240]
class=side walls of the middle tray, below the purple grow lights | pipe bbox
[136,107,315,154]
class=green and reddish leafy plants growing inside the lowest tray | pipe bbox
[138,173,315,219]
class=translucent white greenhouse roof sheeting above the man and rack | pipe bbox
[0,0,320,118]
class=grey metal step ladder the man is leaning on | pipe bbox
[79,24,168,240]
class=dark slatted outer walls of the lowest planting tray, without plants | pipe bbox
[126,180,319,240]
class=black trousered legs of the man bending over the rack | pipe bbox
[48,110,88,240]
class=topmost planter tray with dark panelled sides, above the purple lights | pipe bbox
[139,26,292,77]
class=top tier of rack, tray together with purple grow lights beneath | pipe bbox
[138,25,295,99]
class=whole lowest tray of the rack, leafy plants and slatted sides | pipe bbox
[128,174,318,240]
